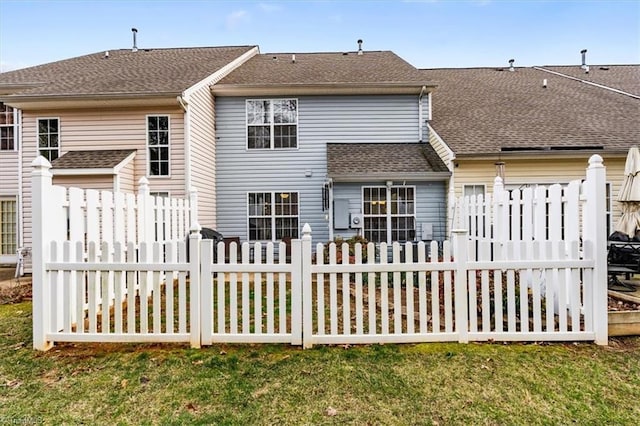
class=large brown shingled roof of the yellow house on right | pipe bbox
[422,66,640,156]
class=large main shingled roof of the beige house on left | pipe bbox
[0,46,254,97]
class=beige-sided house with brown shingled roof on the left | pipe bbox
[0,46,258,263]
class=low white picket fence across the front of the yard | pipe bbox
[33,156,607,350]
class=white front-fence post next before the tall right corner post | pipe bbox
[452,229,469,343]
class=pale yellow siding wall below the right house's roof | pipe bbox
[454,154,626,231]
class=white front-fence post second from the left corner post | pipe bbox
[189,223,201,348]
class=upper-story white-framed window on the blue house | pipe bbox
[247,99,298,149]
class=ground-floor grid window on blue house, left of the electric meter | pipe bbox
[248,192,299,241]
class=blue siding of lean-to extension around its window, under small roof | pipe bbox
[332,181,447,241]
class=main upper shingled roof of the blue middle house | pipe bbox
[214,51,427,95]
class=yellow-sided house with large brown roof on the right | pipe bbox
[421,61,640,232]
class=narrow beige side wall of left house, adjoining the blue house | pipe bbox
[189,85,217,229]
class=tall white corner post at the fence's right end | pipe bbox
[584,154,609,345]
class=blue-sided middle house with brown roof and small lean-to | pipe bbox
[212,48,451,243]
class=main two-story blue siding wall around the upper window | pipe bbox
[216,95,426,241]
